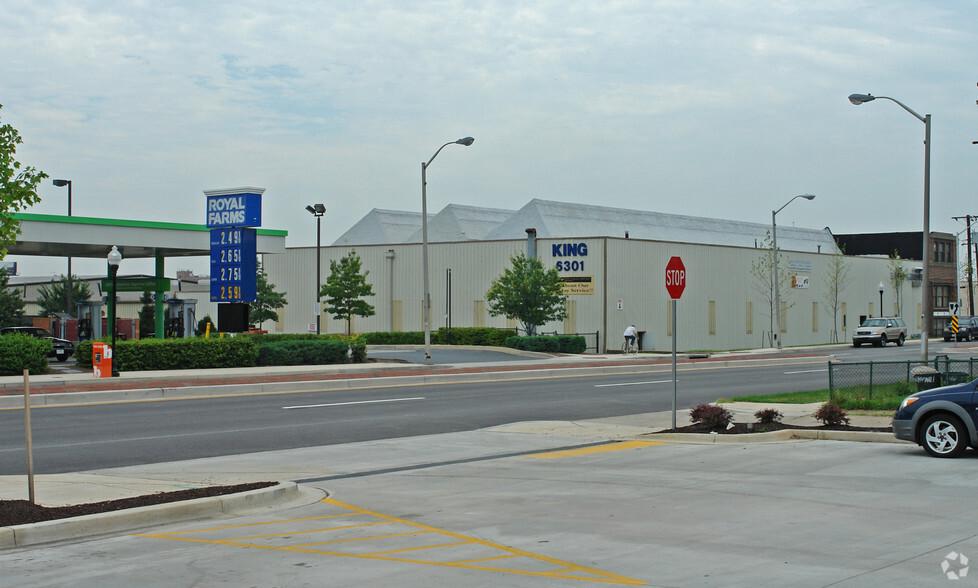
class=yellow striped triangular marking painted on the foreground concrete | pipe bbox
[136,498,648,586]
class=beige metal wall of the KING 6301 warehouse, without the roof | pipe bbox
[262,237,921,352]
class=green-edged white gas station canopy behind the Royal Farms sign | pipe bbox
[7,213,288,259]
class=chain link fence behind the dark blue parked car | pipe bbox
[829,355,978,404]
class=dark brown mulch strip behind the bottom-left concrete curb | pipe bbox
[0,482,278,527]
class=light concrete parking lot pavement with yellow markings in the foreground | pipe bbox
[0,431,978,586]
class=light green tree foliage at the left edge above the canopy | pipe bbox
[0,104,48,259]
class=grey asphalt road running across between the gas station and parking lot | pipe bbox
[0,343,968,475]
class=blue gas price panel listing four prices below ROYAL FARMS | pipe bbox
[211,227,258,302]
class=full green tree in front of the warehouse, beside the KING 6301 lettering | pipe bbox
[486,253,567,333]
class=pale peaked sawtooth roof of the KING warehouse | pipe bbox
[333,198,838,253]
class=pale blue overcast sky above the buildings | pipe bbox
[0,0,978,275]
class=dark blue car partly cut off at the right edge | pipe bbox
[893,380,978,457]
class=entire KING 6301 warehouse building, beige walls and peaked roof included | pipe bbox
[262,199,932,352]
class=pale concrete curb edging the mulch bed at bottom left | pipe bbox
[0,482,308,549]
